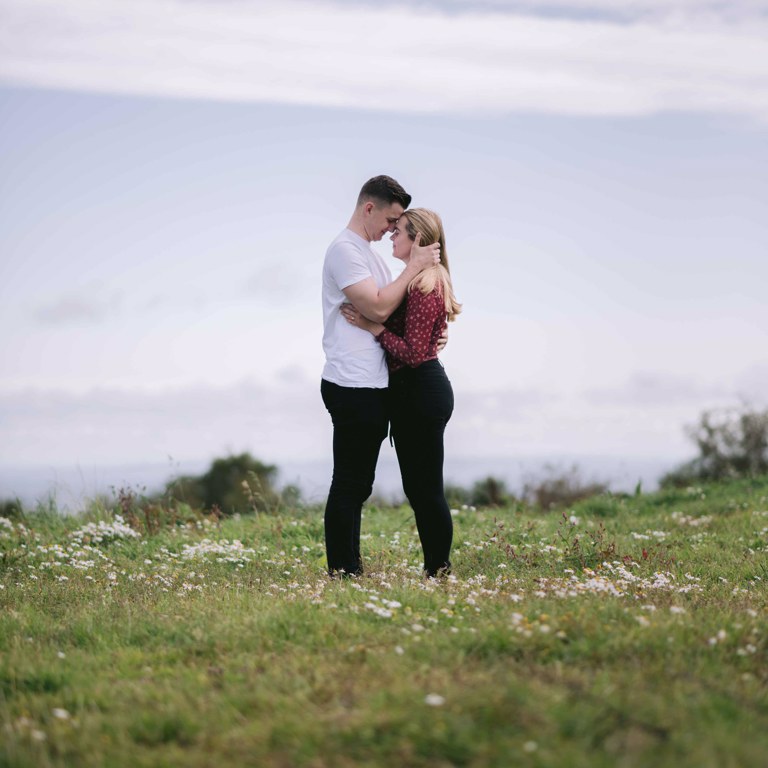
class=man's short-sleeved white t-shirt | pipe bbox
[323,229,392,389]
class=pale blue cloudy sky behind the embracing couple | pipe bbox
[0,0,768,496]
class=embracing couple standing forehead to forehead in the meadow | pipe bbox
[321,176,461,577]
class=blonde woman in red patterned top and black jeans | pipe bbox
[342,208,461,577]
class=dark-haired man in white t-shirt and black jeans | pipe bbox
[320,176,440,576]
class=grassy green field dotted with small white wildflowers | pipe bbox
[0,478,768,768]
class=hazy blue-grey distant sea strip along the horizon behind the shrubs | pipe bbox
[0,449,682,512]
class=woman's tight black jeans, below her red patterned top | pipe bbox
[389,360,453,576]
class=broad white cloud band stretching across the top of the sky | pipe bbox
[0,0,768,121]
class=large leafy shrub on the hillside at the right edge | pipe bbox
[660,406,768,488]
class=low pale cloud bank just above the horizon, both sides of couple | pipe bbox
[0,374,737,465]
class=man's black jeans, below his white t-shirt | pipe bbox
[320,379,389,575]
